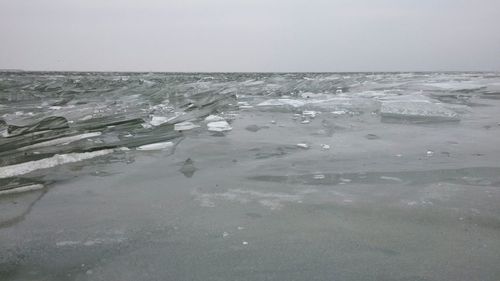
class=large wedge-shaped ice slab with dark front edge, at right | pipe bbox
[380,100,460,122]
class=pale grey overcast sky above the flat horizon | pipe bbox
[0,0,500,71]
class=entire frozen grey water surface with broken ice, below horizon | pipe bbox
[0,72,500,281]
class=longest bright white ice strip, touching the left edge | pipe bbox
[0,149,114,179]
